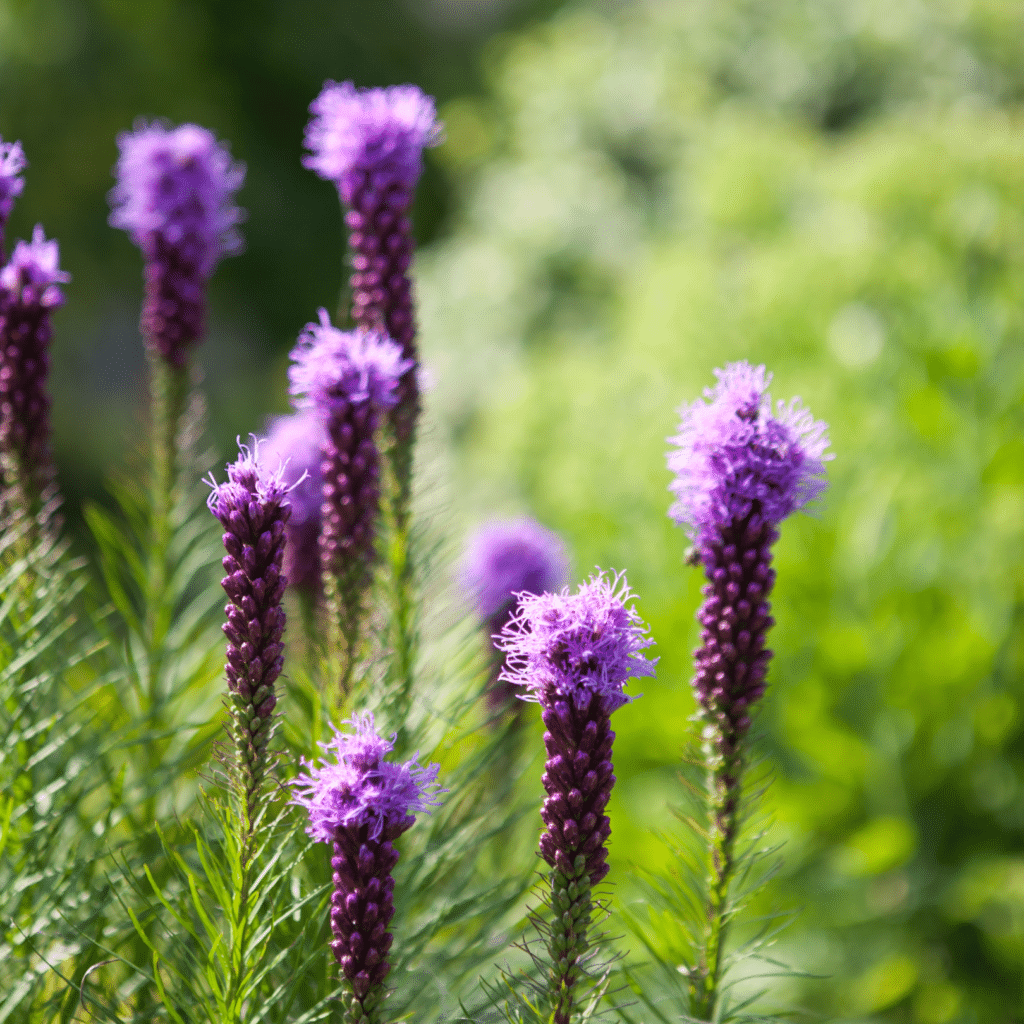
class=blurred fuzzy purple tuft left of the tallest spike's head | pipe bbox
[110,123,246,279]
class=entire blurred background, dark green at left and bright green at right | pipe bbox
[0,0,1024,1024]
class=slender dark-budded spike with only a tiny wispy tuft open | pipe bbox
[209,442,291,829]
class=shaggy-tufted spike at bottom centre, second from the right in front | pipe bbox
[500,572,654,1024]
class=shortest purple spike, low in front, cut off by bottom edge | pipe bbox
[292,714,438,1024]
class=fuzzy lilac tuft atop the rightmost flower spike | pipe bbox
[668,362,831,540]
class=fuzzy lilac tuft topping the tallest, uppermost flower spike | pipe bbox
[303,82,440,203]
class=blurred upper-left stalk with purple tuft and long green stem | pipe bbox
[110,123,245,675]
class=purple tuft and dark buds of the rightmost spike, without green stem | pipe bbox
[669,362,828,741]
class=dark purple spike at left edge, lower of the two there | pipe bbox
[0,225,71,508]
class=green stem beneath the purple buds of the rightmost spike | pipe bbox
[690,715,743,1021]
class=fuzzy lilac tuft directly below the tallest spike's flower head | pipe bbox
[288,309,412,418]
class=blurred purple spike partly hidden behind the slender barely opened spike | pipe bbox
[259,410,327,594]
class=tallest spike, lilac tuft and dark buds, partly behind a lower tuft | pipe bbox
[303,82,441,492]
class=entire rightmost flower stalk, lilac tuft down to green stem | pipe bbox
[669,362,830,1021]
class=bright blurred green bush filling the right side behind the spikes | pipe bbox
[421,3,1024,1024]
